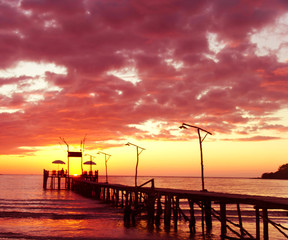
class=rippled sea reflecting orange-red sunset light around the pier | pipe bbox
[0,175,288,240]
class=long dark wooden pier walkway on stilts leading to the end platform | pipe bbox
[71,178,288,240]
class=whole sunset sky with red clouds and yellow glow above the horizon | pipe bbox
[0,0,288,177]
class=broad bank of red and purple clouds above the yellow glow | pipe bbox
[0,0,288,153]
